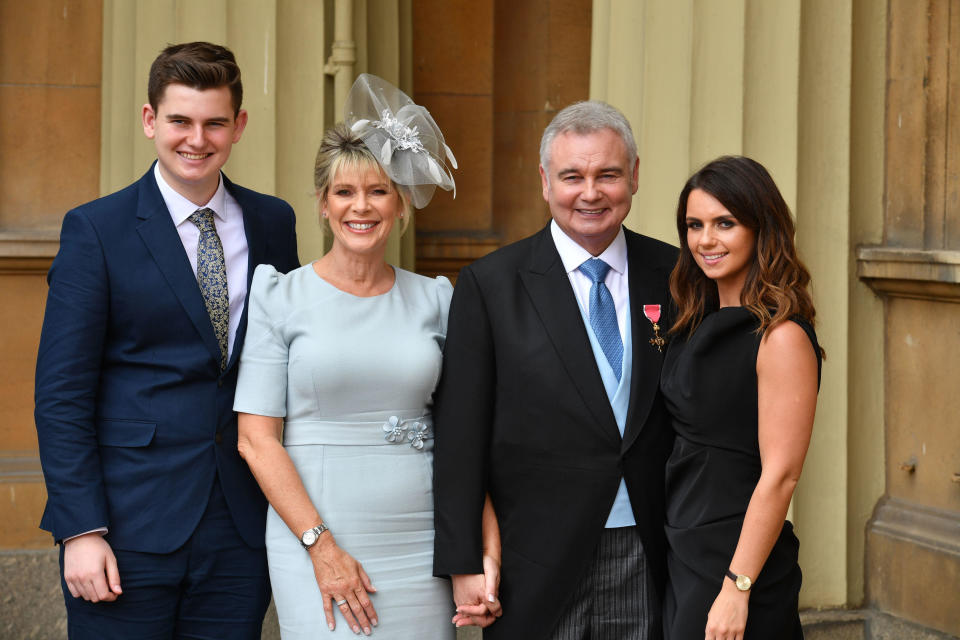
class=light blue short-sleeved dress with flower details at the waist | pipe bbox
[234,265,455,640]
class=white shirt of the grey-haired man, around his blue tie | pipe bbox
[550,220,630,342]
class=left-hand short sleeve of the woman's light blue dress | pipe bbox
[233,264,289,418]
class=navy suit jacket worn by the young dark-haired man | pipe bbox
[35,168,298,553]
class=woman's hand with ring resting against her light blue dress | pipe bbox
[309,532,379,635]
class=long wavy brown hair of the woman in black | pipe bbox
[670,156,823,354]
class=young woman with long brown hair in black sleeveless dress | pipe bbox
[661,156,823,640]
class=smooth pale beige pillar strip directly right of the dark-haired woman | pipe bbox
[795,0,853,606]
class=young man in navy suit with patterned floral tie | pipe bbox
[35,42,298,639]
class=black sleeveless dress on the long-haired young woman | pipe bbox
[660,307,820,640]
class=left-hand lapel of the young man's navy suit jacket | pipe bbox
[137,167,220,362]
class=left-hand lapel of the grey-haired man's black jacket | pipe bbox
[520,225,620,443]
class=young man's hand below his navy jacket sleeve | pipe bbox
[63,532,123,602]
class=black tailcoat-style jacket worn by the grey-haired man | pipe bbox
[434,222,677,639]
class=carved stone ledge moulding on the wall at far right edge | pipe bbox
[857,246,960,303]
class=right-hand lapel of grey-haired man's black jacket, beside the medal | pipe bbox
[622,231,670,451]
